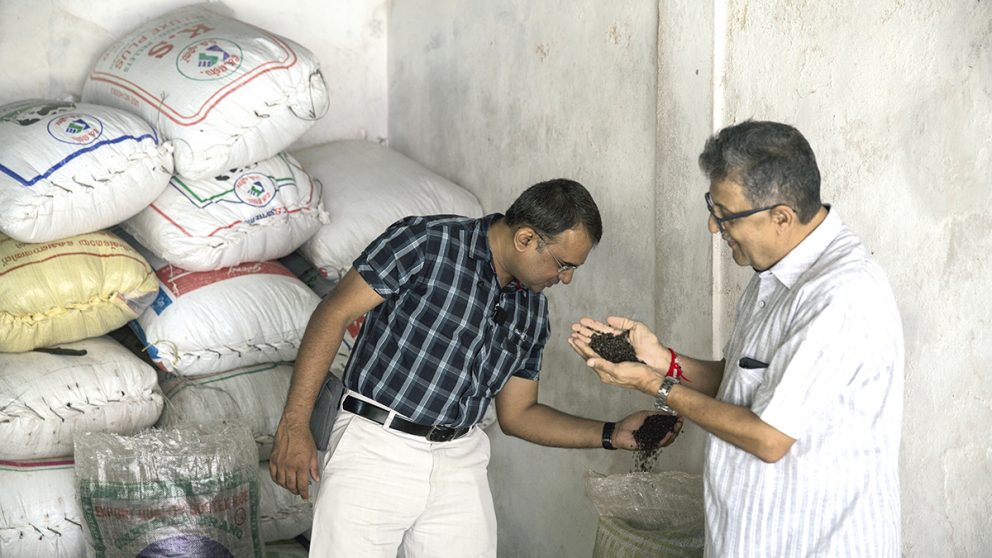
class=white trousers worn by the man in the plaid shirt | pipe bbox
[310,400,496,558]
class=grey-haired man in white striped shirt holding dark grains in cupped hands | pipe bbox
[569,121,904,558]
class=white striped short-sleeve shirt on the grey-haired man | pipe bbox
[705,210,903,558]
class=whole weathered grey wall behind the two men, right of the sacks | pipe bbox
[389,0,992,557]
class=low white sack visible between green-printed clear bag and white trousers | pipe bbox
[258,461,313,555]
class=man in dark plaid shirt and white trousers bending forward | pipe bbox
[270,179,676,558]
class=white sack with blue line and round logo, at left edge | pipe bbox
[0,99,172,242]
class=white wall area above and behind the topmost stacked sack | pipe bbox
[0,0,388,149]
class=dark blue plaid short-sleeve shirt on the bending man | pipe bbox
[344,214,550,427]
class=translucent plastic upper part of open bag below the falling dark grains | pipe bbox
[586,471,703,530]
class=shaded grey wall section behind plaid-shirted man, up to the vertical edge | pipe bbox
[389,0,658,557]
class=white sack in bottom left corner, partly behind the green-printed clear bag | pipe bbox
[0,457,86,558]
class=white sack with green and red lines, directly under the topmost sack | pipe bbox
[121,153,327,271]
